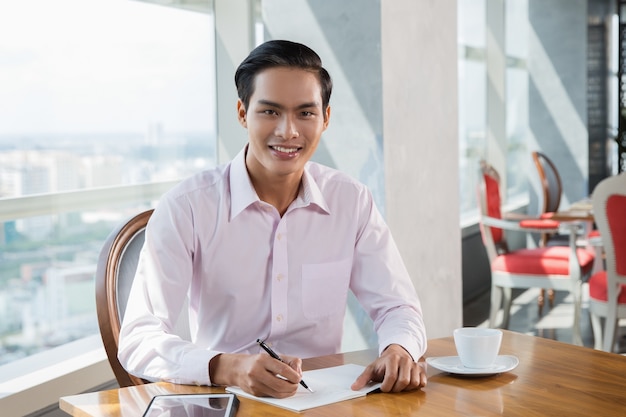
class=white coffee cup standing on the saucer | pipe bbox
[454,327,502,368]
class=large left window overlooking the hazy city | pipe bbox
[0,0,216,364]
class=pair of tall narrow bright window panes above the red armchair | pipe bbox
[458,0,530,224]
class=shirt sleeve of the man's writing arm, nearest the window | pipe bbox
[118,197,219,385]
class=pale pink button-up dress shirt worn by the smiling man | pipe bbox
[118,146,426,385]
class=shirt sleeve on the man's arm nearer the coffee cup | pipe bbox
[351,186,427,361]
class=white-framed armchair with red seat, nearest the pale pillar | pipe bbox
[478,161,595,345]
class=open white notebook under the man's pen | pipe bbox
[226,364,381,411]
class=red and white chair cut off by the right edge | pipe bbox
[589,173,626,352]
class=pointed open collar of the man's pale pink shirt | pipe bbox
[230,145,330,220]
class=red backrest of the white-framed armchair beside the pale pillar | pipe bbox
[478,160,507,261]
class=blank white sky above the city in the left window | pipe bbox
[0,0,214,135]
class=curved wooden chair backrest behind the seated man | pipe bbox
[96,209,153,387]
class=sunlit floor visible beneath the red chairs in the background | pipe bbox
[463,287,626,353]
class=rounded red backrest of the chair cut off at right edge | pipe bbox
[591,173,626,300]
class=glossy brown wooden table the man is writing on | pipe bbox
[59,331,626,417]
